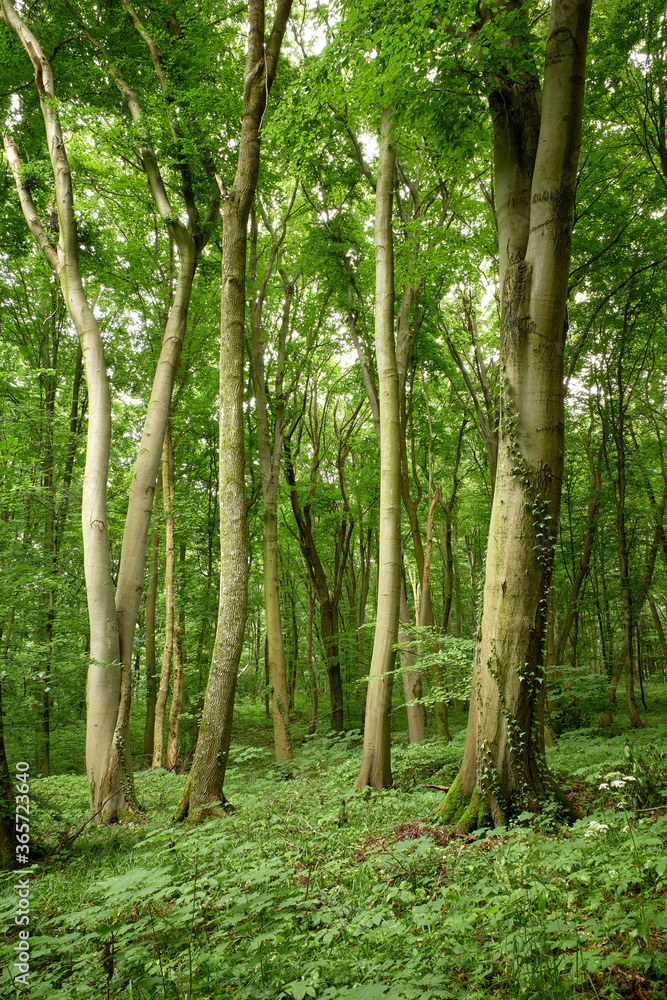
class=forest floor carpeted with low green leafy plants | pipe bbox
[0,688,667,1000]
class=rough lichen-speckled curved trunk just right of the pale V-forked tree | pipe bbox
[176,0,292,820]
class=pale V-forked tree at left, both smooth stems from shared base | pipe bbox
[1,0,202,822]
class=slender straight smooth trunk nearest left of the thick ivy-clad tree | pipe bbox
[357,110,401,788]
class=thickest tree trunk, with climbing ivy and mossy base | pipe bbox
[441,0,590,829]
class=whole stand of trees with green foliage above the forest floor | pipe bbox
[0,0,667,865]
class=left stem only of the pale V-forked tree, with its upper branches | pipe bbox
[2,0,122,816]
